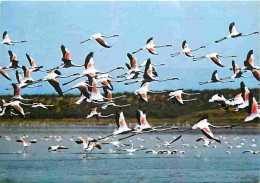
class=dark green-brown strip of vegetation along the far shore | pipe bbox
[1,89,260,126]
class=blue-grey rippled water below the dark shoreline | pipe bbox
[0,126,260,183]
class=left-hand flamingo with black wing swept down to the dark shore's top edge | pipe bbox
[34,69,78,96]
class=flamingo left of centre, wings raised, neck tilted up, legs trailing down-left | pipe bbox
[63,52,124,85]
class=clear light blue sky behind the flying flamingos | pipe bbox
[0,1,260,95]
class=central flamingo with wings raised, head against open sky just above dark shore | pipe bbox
[125,59,178,85]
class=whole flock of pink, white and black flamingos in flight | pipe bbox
[0,22,260,154]
